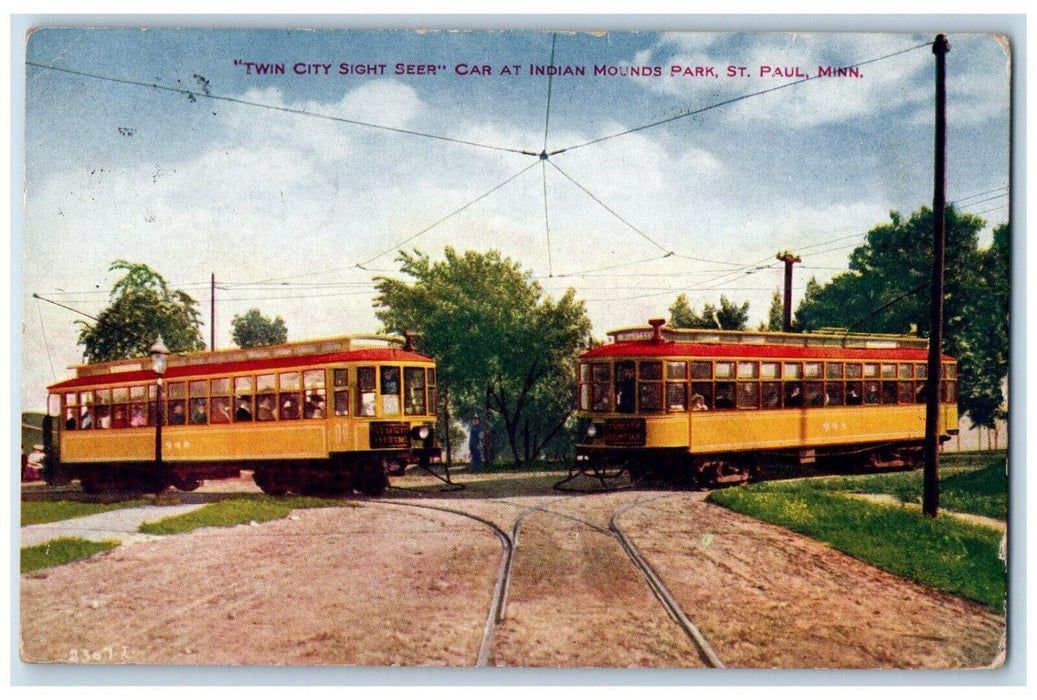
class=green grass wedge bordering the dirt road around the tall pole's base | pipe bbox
[708,487,1006,611]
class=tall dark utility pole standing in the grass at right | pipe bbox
[922,34,951,517]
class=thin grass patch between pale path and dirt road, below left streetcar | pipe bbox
[139,496,359,535]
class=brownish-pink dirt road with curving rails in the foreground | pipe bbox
[21,475,1005,669]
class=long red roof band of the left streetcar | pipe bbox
[48,347,435,391]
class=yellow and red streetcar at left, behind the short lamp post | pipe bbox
[46,335,440,496]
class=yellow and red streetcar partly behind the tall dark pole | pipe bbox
[577,319,958,485]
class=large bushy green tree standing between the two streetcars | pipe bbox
[374,248,590,466]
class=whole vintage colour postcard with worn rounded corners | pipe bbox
[17,26,1013,682]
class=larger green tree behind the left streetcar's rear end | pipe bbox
[76,260,205,363]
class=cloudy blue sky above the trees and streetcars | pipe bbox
[16,28,1010,409]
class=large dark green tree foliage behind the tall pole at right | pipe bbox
[795,206,1009,425]
